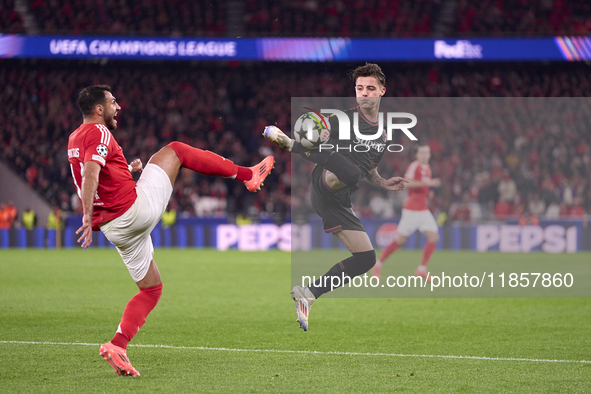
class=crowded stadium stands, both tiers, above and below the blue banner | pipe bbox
[0,0,591,220]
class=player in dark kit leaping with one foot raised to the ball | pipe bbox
[263,63,408,331]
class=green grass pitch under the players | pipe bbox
[0,249,591,393]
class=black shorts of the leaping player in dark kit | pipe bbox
[311,168,365,233]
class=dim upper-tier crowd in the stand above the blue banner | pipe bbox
[0,0,591,37]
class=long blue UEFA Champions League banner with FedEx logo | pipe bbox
[0,34,591,62]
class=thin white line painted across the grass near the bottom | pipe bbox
[0,341,591,364]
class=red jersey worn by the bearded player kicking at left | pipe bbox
[68,123,137,231]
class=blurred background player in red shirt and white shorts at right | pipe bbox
[372,145,441,280]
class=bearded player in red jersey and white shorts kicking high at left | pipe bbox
[68,85,275,376]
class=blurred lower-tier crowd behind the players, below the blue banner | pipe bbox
[0,60,591,222]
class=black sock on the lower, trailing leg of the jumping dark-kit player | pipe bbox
[309,250,376,298]
